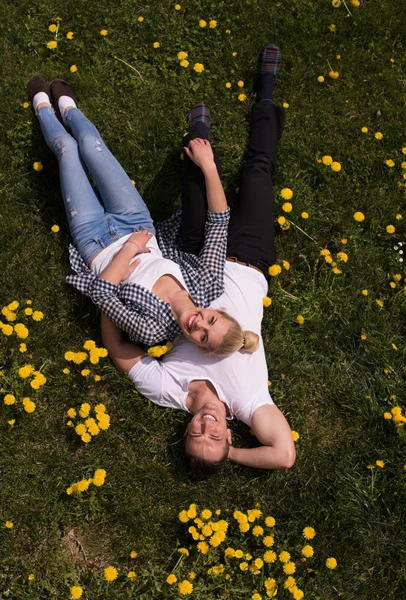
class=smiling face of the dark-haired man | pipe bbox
[185,402,231,461]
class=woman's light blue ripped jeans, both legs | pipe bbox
[37,106,155,264]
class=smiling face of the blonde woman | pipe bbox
[179,307,230,350]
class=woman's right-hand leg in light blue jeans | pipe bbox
[65,108,155,233]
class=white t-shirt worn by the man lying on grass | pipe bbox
[128,262,273,425]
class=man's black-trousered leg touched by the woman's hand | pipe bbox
[181,106,221,255]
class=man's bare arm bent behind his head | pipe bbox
[228,404,296,469]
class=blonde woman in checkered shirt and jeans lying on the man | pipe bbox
[28,75,257,354]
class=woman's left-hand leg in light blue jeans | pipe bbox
[37,106,105,262]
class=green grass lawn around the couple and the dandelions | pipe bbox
[0,0,406,600]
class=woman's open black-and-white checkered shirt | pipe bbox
[66,210,230,346]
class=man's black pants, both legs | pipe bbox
[182,101,284,280]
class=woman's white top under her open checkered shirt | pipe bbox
[90,234,187,292]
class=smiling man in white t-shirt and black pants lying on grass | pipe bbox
[102,44,295,474]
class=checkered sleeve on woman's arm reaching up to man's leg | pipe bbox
[199,209,230,286]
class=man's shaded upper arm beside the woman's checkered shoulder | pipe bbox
[101,313,147,373]
